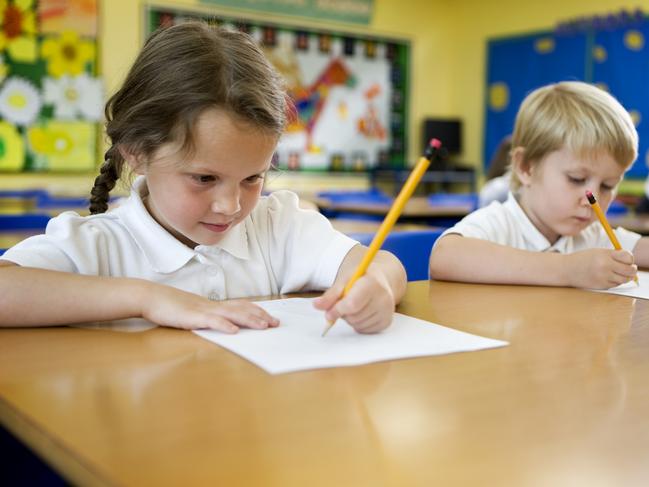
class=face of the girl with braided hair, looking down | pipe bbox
[127,109,277,248]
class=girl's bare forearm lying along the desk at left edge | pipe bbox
[0,266,152,326]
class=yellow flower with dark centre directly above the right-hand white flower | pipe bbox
[41,30,95,78]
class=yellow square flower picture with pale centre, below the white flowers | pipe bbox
[27,120,96,171]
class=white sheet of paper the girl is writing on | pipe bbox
[194,298,507,374]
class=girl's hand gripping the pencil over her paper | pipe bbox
[314,274,395,333]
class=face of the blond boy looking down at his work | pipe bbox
[517,148,624,243]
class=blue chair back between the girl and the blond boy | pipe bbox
[347,228,444,281]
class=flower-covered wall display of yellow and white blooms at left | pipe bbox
[0,0,103,173]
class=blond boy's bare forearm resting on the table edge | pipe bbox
[430,235,572,286]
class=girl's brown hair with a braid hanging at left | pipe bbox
[90,22,287,214]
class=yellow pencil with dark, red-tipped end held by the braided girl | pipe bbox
[322,139,442,337]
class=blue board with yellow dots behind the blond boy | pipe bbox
[484,15,649,178]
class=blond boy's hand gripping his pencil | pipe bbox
[566,249,638,289]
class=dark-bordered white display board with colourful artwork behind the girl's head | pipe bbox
[146,5,410,171]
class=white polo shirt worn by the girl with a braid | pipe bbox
[1,178,358,300]
